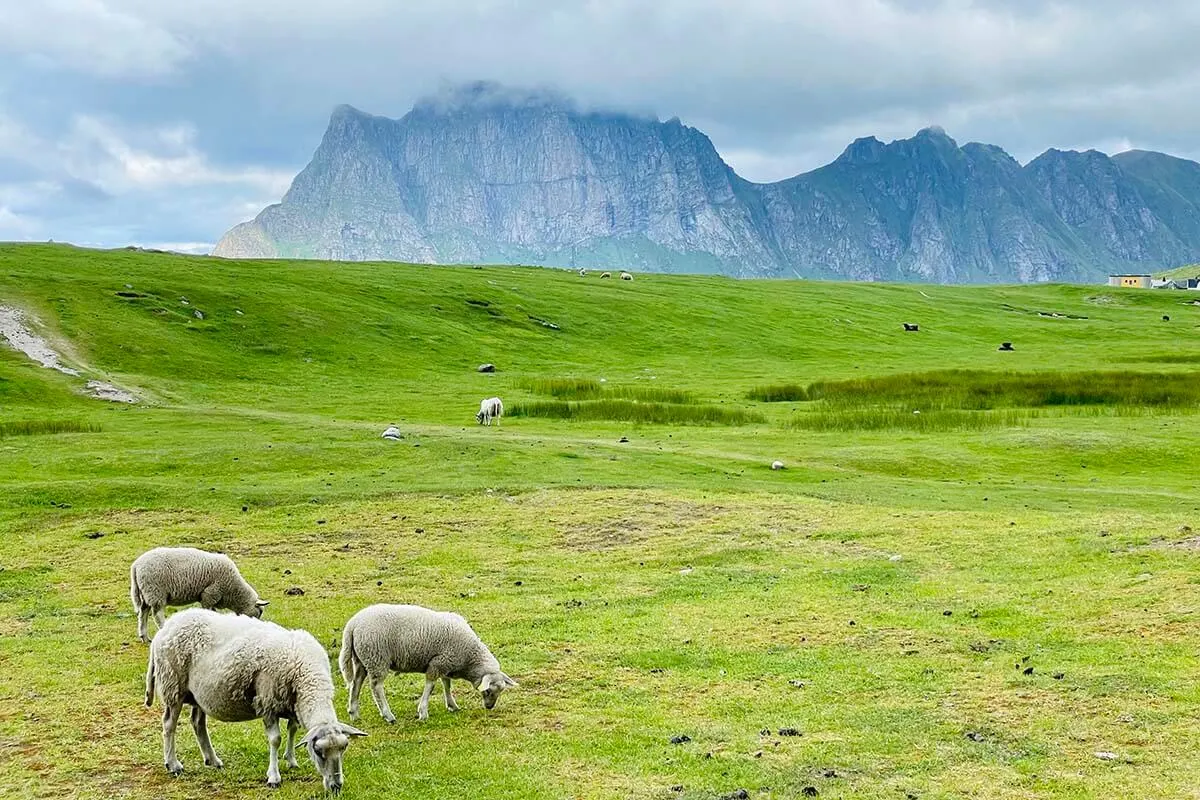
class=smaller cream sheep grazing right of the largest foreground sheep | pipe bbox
[338,603,517,723]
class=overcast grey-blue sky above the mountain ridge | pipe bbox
[0,0,1200,249]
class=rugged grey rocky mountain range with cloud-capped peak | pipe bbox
[214,84,1200,283]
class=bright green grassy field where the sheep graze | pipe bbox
[0,245,1200,800]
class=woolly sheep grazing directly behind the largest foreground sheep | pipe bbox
[130,547,269,642]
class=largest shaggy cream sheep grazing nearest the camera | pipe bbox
[145,608,367,792]
